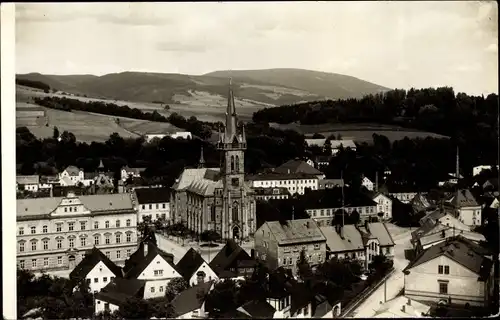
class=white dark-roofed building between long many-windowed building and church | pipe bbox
[134,188,170,222]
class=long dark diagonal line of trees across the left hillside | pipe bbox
[33,97,212,139]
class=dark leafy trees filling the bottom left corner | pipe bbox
[17,269,94,319]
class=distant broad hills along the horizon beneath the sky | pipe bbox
[17,69,386,109]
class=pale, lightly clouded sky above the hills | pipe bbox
[16,1,498,95]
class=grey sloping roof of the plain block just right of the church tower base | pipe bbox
[265,219,326,245]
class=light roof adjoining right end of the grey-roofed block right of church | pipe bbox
[320,224,365,252]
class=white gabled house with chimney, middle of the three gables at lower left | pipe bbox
[123,238,182,299]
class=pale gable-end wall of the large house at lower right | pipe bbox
[405,256,485,306]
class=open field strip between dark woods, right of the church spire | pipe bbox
[272,123,448,143]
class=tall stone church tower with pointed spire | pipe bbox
[217,80,255,239]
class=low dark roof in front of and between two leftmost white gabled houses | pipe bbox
[95,278,146,306]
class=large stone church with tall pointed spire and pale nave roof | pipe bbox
[170,84,257,240]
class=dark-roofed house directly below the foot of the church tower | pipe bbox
[209,240,257,279]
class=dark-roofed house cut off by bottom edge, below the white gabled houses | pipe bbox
[172,281,214,319]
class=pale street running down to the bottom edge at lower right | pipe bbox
[352,228,412,318]
